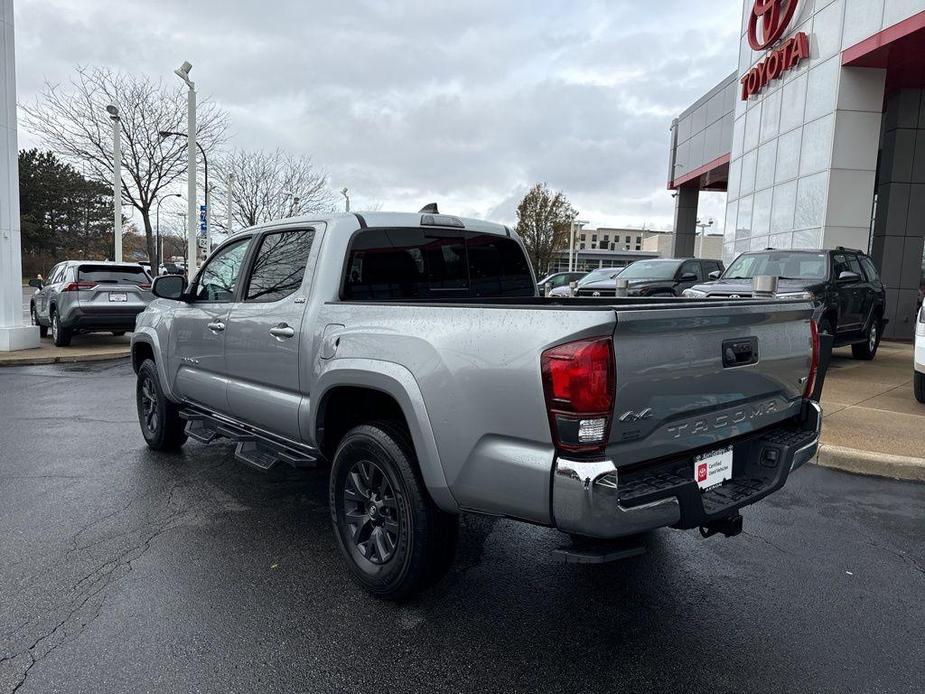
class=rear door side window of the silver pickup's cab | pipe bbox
[244,229,315,302]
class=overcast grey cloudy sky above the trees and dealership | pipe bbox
[14,0,741,234]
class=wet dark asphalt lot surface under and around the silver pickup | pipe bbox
[0,360,925,693]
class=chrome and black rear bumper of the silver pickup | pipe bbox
[552,402,822,538]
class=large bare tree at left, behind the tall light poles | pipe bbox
[21,66,228,258]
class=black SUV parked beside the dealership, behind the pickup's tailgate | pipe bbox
[684,248,886,359]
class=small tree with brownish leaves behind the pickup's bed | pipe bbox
[517,183,578,276]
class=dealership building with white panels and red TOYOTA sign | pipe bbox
[669,0,925,337]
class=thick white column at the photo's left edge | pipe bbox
[0,0,39,352]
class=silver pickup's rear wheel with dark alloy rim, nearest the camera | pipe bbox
[329,422,459,600]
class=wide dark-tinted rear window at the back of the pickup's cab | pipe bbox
[343,229,536,301]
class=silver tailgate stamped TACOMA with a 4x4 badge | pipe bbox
[607,301,812,467]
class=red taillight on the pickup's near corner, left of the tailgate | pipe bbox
[540,337,617,453]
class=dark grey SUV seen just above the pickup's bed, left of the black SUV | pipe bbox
[578,258,723,297]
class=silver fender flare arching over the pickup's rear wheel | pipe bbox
[307,359,459,513]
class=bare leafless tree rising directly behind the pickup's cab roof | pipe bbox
[212,149,337,227]
